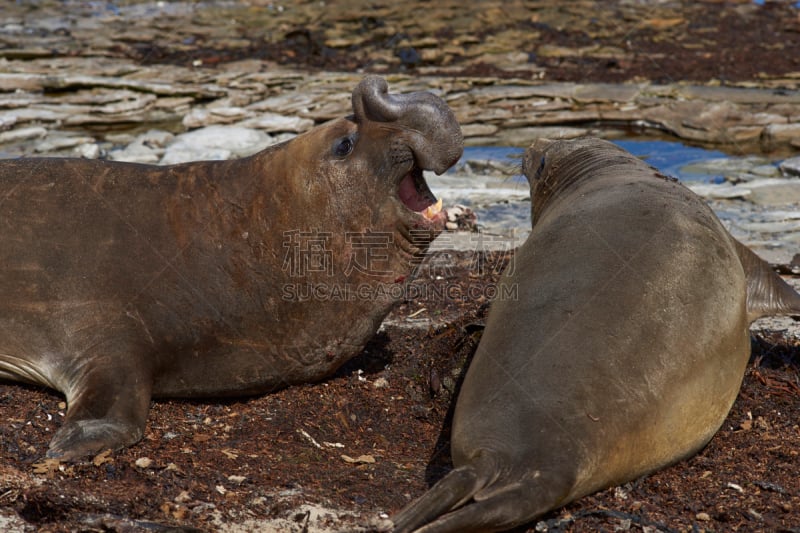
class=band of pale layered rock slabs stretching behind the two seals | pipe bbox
[0,58,800,157]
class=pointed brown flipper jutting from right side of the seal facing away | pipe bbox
[734,239,800,322]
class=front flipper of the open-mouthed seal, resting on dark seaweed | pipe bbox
[47,353,152,461]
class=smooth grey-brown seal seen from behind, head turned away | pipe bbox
[393,139,800,533]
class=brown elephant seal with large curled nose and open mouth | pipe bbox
[0,77,462,460]
